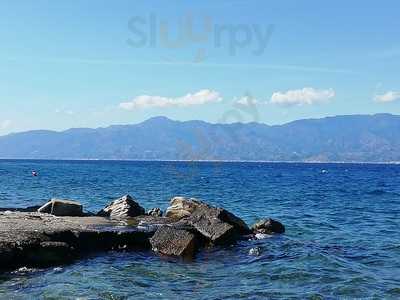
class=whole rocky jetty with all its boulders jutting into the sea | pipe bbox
[0,195,285,270]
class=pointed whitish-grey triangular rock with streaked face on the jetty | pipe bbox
[97,195,145,218]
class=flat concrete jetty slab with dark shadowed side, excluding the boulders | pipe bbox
[0,212,154,271]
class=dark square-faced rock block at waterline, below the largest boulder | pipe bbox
[150,226,196,257]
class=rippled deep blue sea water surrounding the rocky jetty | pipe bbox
[0,160,400,299]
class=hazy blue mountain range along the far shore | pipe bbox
[0,114,400,162]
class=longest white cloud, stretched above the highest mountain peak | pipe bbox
[119,90,222,110]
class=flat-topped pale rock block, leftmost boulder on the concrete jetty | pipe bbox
[37,199,83,217]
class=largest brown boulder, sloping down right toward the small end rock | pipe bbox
[167,197,251,244]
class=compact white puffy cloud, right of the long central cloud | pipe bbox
[270,87,336,106]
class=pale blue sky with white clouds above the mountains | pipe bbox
[0,0,400,135]
